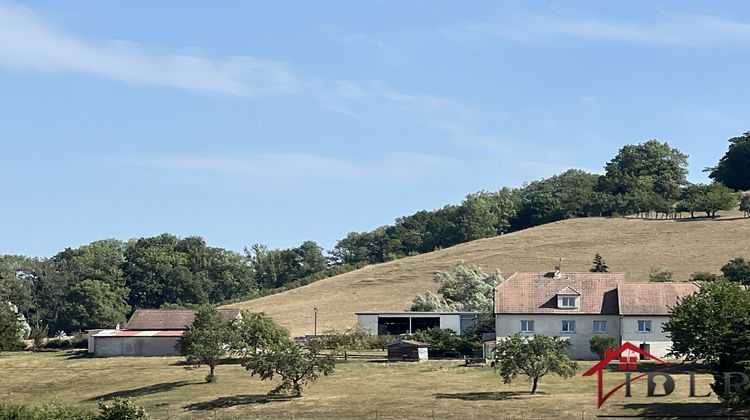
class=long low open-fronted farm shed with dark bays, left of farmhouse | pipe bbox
[355,312,479,335]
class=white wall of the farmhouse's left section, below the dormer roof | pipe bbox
[495,312,620,360]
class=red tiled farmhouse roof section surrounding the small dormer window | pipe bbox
[495,272,625,315]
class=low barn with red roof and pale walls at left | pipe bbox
[89,309,240,357]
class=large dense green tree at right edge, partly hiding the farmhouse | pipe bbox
[663,279,750,405]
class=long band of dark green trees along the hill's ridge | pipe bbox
[0,133,750,332]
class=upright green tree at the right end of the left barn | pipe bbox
[177,305,231,383]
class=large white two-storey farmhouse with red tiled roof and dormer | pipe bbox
[495,271,698,359]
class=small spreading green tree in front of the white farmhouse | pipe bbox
[492,334,578,394]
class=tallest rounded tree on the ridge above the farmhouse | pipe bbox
[600,140,688,199]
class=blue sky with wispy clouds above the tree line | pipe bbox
[0,0,750,256]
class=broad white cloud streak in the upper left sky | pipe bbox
[0,2,302,95]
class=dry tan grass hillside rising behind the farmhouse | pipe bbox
[229,212,750,335]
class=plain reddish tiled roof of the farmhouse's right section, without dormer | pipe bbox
[618,283,698,315]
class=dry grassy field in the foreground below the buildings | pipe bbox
[0,352,740,419]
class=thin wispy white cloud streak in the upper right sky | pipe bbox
[460,13,750,47]
